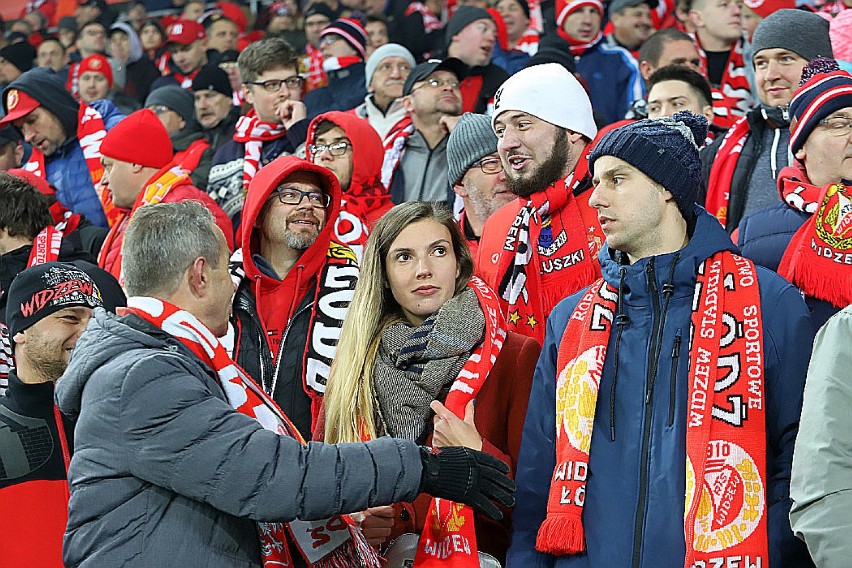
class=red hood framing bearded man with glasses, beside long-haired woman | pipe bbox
[239,156,340,292]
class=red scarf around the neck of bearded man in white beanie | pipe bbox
[497,166,601,345]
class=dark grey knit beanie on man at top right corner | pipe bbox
[751,8,834,61]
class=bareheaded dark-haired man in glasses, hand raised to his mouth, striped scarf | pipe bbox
[207,37,308,227]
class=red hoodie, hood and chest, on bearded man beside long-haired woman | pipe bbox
[239,156,340,359]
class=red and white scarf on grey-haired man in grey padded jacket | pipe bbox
[119,296,380,568]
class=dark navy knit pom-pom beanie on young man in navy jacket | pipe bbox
[589,111,707,219]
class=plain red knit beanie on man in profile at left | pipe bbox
[101,108,172,169]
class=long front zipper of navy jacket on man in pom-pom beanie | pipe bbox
[632,257,661,568]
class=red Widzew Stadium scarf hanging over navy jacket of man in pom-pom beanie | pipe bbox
[536,252,769,568]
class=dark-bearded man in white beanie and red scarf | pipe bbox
[476,63,604,343]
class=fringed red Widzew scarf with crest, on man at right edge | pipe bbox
[778,166,852,308]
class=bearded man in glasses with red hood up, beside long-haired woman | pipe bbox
[231,154,358,439]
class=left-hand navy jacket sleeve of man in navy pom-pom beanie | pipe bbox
[506,299,573,568]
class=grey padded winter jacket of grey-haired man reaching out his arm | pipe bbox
[56,309,422,568]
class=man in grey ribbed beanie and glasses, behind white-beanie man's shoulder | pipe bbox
[447,112,516,258]
